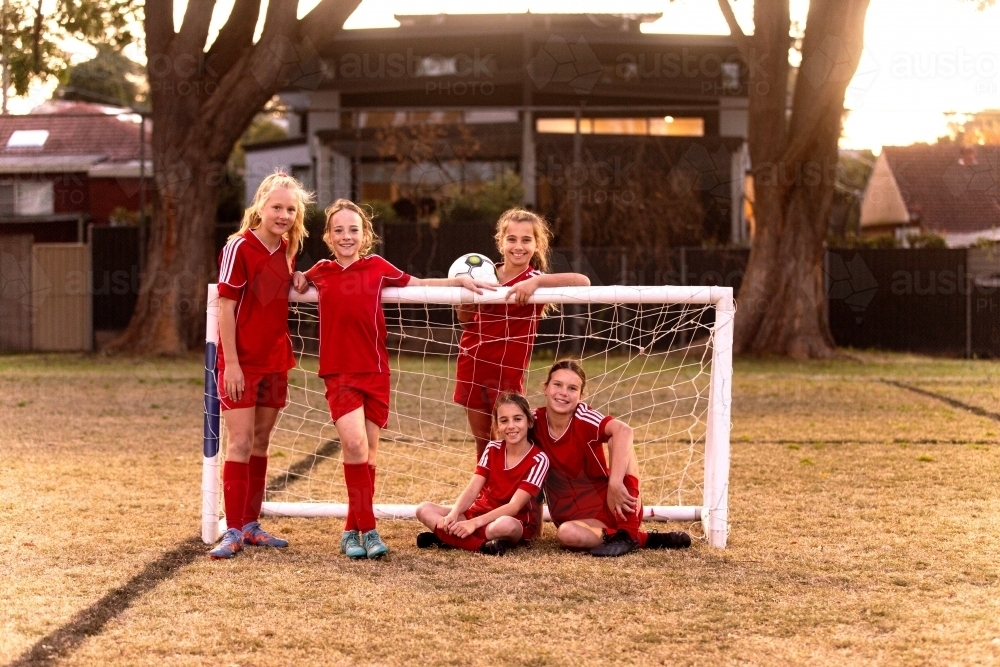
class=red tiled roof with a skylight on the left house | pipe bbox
[0,104,150,162]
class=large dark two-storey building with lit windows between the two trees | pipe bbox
[246,13,748,242]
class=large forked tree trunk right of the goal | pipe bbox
[719,0,869,358]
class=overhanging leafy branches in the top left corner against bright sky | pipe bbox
[2,0,143,95]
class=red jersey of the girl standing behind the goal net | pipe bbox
[457,265,545,390]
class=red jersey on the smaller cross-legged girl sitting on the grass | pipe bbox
[469,440,549,525]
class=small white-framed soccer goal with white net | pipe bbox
[202,285,735,548]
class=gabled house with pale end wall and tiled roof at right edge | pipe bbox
[861,144,1000,248]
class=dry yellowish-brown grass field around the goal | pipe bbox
[0,353,1000,666]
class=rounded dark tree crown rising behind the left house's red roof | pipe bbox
[55,44,145,107]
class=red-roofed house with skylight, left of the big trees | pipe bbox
[0,102,152,242]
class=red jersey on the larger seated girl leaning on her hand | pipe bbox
[532,403,614,525]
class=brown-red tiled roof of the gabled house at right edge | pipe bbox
[882,144,1000,234]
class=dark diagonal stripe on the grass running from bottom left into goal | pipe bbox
[9,440,340,667]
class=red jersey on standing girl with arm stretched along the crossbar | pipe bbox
[306,255,410,377]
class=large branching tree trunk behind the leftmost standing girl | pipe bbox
[115,0,359,354]
